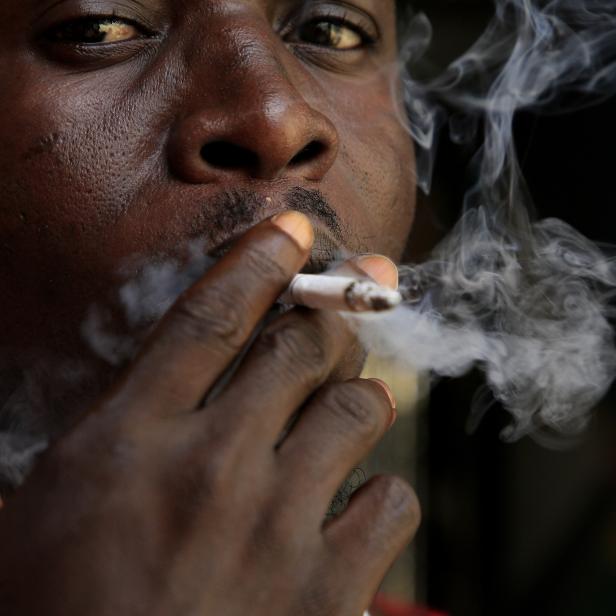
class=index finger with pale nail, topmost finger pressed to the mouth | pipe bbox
[115,211,314,414]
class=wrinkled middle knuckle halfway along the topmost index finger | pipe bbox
[176,286,248,350]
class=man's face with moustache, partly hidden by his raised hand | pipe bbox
[0,0,414,410]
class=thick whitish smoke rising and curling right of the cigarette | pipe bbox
[356,0,616,440]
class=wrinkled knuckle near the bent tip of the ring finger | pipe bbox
[326,382,384,440]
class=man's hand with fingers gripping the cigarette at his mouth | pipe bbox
[0,213,419,616]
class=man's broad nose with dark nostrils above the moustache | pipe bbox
[170,31,338,183]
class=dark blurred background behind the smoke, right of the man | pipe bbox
[366,0,616,616]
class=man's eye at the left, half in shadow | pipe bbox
[49,17,143,45]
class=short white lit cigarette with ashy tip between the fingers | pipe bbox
[280,274,402,312]
